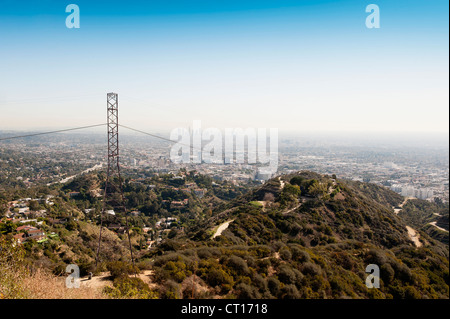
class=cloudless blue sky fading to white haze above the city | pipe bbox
[0,0,449,132]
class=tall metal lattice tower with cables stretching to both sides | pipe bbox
[95,93,134,266]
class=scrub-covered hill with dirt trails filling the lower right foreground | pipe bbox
[146,172,448,298]
